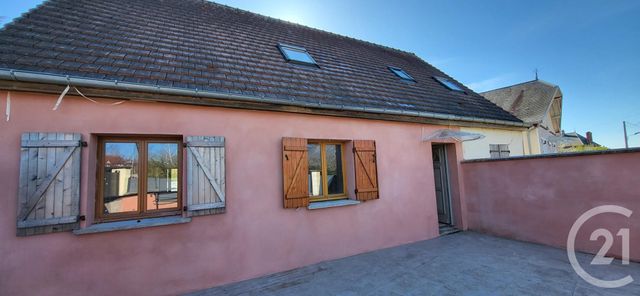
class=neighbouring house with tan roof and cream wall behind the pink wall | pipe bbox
[461,79,562,159]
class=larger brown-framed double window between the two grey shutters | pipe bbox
[95,135,182,222]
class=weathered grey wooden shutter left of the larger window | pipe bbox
[17,132,82,236]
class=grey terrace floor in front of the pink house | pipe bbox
[190,232,640,296]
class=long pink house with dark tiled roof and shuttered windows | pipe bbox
[0,0,528,295]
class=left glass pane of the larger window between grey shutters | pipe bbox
[102,142,139,214]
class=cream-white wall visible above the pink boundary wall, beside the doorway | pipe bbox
[460,127,533,159]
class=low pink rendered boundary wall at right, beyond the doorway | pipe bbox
[462,151,640,261]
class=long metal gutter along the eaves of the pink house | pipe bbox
[0,69,530,127]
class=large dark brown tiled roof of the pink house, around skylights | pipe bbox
[0,0,520,122]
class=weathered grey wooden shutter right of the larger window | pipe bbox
[186,136,226,216]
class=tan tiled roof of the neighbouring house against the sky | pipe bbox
[480,80,558,123]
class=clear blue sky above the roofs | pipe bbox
[0,0,640,148]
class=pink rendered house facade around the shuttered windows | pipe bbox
[0,92,465,295]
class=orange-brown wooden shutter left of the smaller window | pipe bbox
[282,138,309,208]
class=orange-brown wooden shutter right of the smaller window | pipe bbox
[353,140,379,201]
